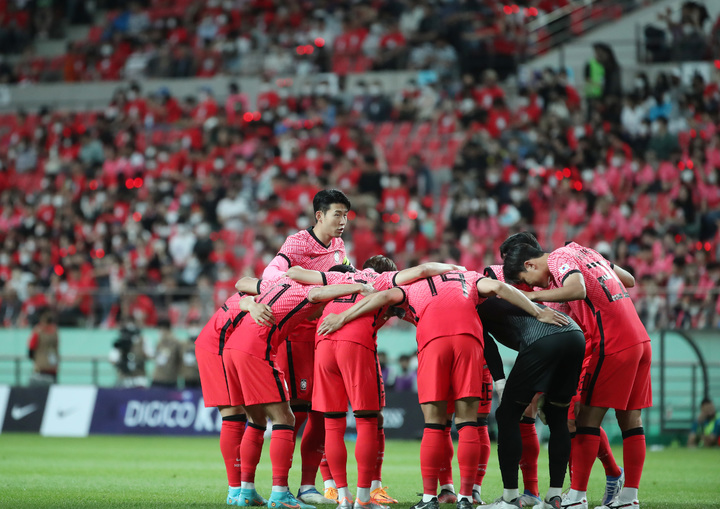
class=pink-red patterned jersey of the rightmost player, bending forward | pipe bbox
[548,242,650,355]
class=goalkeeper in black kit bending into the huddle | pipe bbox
[478,282,585,509]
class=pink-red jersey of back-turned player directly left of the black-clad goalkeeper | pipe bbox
[400,271,484,351]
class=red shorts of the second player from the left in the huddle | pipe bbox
[223,349,290,406]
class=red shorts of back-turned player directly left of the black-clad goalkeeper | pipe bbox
[417,334,484,403]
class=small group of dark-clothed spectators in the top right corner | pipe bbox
[645,0,720,62]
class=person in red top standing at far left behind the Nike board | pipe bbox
[28,308,60,385]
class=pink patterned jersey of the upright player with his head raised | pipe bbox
[278,228,345,271]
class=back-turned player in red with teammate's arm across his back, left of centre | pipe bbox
[287,255,463,509]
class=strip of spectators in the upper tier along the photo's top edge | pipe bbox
[0,0,641,83]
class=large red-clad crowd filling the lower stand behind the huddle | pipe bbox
[0,49,720,329]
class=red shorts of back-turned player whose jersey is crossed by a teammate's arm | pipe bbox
[312,340,385,412]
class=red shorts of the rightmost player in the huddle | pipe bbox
[581,341,652,410]
